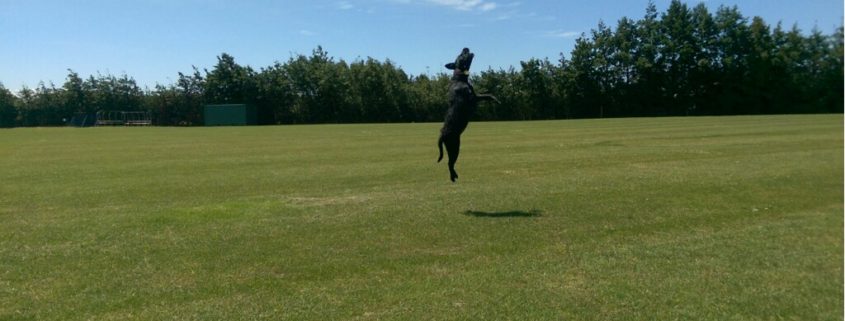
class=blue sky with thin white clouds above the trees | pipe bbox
[0,0,843,91]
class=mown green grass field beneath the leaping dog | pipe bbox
[0,115,843,320]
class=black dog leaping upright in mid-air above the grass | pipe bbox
[437,48,499,182]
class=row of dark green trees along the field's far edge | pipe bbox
[0,0,845,127]
